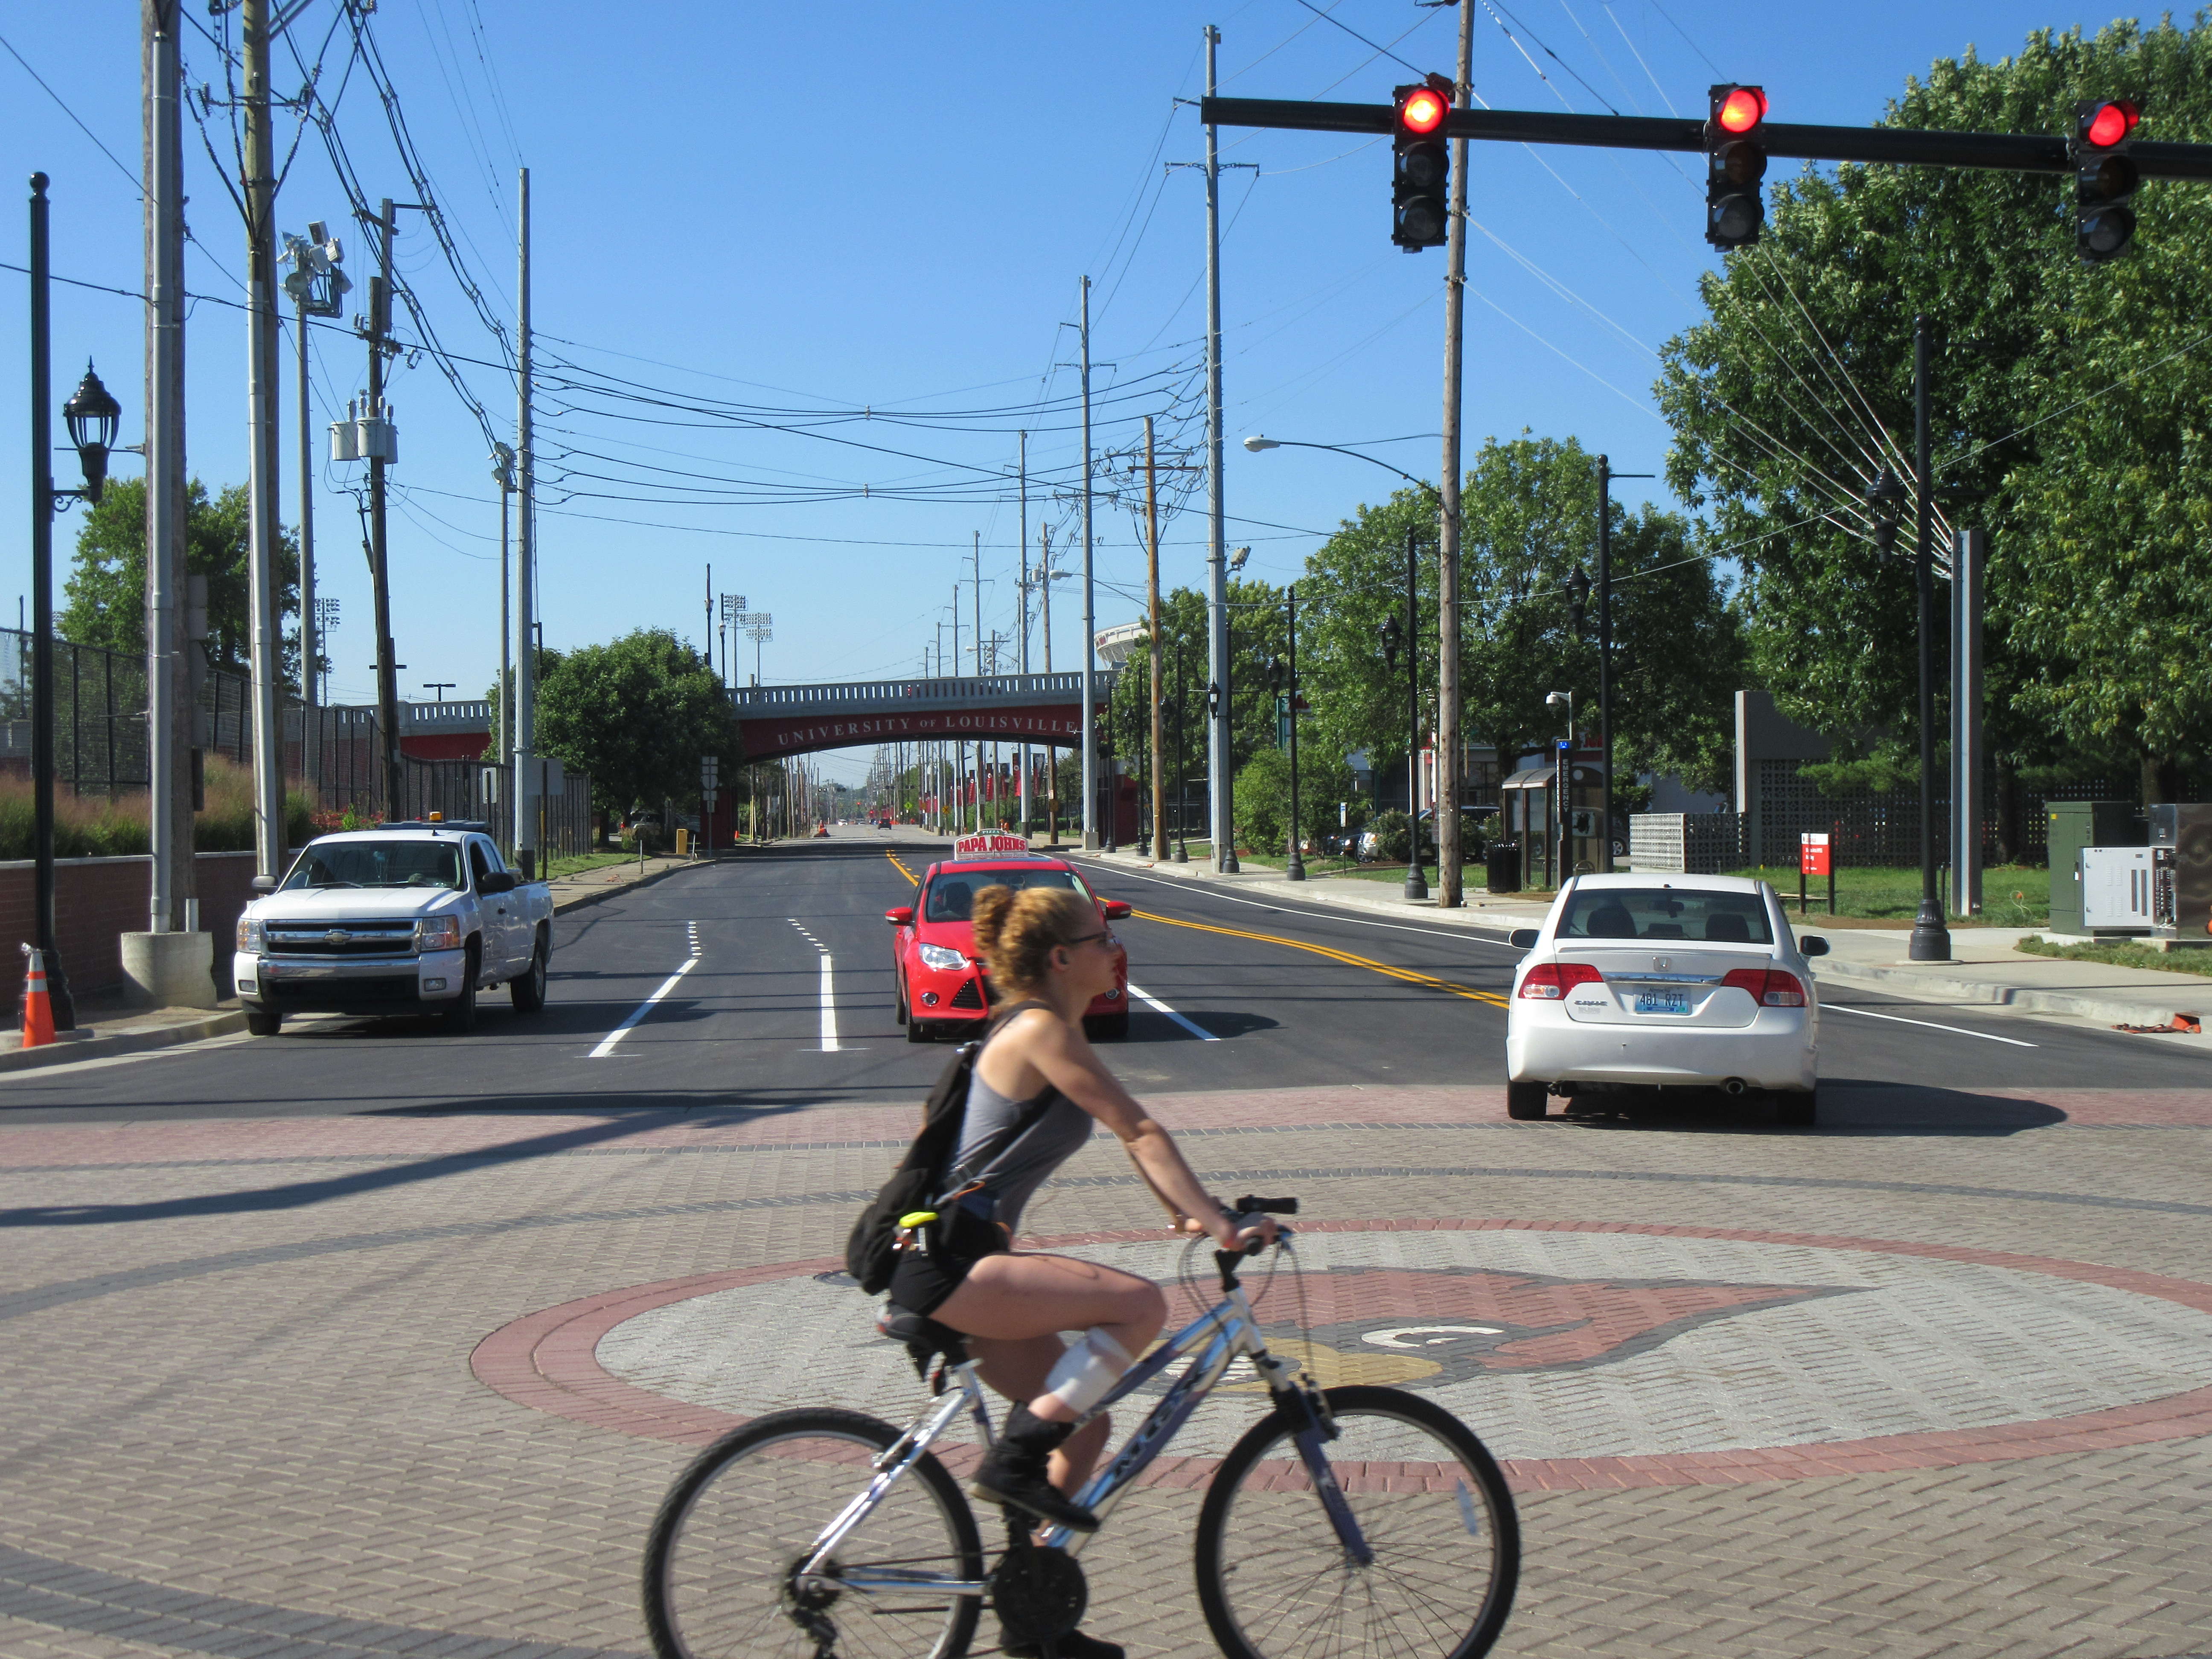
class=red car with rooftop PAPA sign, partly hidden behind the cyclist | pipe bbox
[882,854,1128,1042]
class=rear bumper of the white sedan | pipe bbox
[1506,1009,1820,1089]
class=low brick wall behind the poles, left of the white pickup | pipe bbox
[0,852,254,1000]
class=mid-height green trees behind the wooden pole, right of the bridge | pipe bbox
[1298,436,1743,788]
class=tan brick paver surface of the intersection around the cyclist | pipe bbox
[0,1089,2212,1659]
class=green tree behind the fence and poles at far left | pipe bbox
[58,478,299,684]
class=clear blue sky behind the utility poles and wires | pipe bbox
[0,0,2106,777]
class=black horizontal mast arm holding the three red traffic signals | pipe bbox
[1199,97,2212,179]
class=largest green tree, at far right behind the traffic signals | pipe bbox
[1659,15,2212,818]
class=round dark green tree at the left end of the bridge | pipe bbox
[538,628,741,812]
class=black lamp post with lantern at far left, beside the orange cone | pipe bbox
[31,172,124,1031]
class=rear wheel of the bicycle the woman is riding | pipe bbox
[644,1409,984,1659]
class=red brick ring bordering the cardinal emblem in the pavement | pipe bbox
[469,1221,2212,1491]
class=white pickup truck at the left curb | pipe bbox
[230,818,553,1037]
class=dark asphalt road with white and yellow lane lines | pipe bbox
[0,832,2208,1135]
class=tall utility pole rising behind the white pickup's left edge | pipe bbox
[239,0,283,876]
